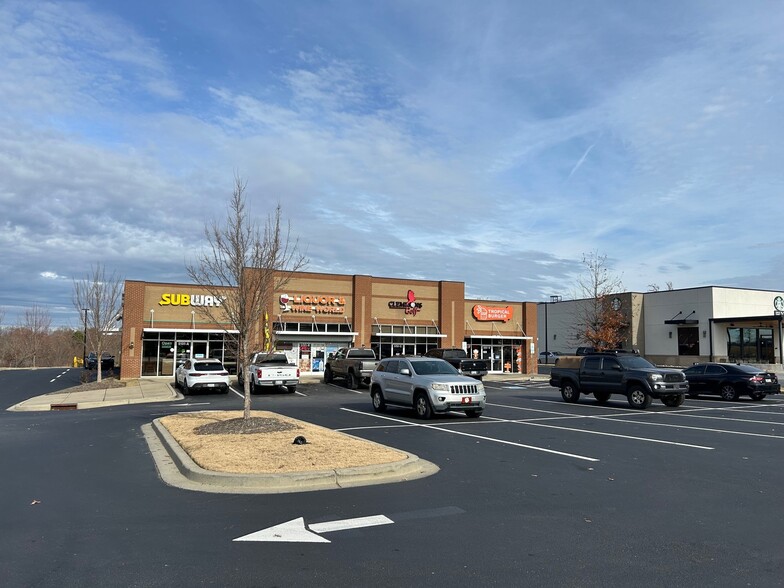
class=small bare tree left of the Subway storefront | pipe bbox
[73,263,123,382]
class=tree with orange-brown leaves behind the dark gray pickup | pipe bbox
[574,251,627,349]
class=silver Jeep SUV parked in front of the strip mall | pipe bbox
[370,357,486,419]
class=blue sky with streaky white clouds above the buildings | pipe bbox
[0,0,784,327]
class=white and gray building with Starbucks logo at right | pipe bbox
[537,286,784,366]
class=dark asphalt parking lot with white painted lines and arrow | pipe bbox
[0,370,784,586]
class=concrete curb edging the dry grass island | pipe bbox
[147,419,439,494]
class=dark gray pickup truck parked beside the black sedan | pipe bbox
[550,351,689,409]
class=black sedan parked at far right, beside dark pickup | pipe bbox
[683,362,781,400]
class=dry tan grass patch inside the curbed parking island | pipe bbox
[160,410,407,474]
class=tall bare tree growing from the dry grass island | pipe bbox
[186,175,307,423]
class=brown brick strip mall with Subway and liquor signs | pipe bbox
[121,270,538,378]
